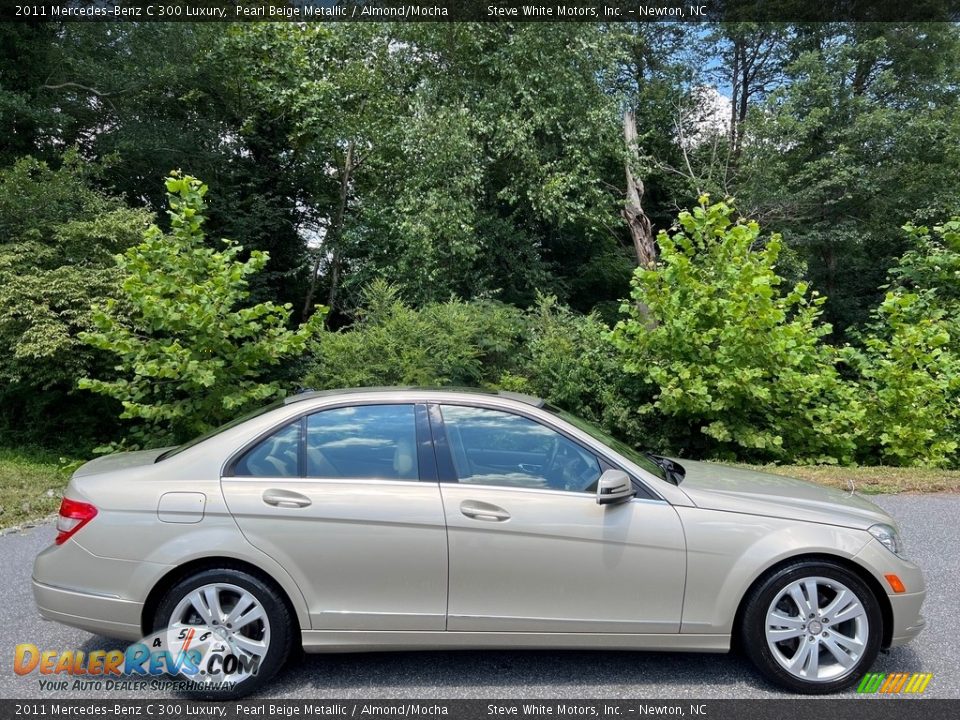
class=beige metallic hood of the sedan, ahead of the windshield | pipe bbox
[677,460,893,529]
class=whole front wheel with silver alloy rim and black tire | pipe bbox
[740,560,883,695]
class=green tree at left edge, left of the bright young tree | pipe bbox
[0,152,150,450]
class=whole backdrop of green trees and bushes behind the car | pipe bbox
[0,22,960,466]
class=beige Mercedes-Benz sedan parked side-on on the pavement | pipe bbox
[33,388,925,697]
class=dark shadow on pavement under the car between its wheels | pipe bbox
[264,650,782,699]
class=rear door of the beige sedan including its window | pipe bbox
[221,404,447,630]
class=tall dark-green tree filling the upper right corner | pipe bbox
[732,23,960,331]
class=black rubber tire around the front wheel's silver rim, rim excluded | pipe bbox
[741,560,883,695]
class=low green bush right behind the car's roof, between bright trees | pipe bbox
[303,280,522,389]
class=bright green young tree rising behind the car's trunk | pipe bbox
[80,173,324,442]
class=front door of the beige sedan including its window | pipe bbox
[431,405,686,633]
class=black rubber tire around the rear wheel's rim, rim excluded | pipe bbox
[153,569,293,700]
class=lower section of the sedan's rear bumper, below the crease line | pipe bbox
[33,579,143,640]
